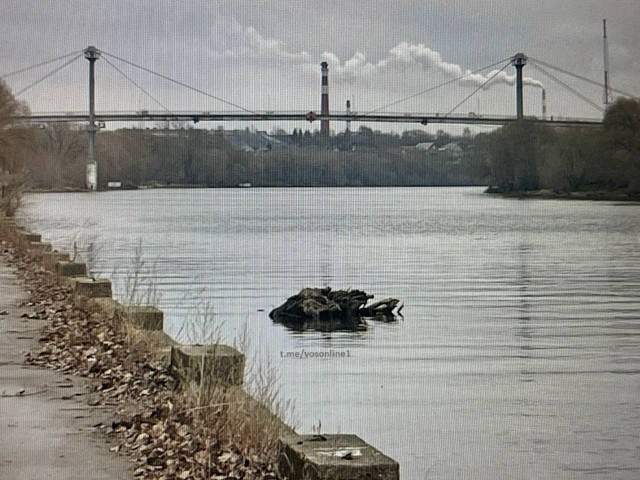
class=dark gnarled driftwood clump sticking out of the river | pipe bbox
[269,287,402,330]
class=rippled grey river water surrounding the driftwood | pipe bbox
[19,188,640,480]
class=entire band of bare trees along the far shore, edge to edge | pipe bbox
[0,74,640,208]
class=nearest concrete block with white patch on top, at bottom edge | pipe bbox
[277,435,400,480]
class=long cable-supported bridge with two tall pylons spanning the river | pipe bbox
[0,46,633,190]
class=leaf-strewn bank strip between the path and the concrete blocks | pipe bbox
[0,222,280,479]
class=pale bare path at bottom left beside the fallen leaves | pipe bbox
[0,257,132,480]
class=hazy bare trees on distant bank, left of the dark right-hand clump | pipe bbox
[12,120,483,189]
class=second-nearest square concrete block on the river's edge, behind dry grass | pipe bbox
[171,345,245,385]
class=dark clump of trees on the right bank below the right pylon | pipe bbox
[472,98,640,195]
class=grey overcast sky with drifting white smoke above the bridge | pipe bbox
[0,0,640,133]
